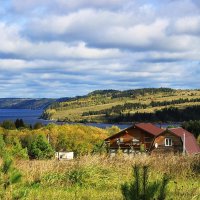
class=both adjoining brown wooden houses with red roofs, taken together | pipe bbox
[105,123,200,155]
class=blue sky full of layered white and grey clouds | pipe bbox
[0,0,200,98]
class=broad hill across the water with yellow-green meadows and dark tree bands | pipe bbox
[42,88,200,123]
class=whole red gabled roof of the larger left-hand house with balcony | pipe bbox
[105,123,163,140]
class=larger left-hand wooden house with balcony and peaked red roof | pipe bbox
[105,123,163,155]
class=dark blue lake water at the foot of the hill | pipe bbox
[0,109,130,129]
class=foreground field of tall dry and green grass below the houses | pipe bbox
[3,155,200,200]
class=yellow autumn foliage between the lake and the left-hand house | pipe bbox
[0,124,109,155]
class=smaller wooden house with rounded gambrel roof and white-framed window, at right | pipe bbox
[150,127,200,154]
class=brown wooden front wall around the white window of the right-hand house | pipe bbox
[151,131,183,154]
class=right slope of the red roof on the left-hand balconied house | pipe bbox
[135,123,163,136]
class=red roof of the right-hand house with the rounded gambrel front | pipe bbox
[169,128,200,154]
